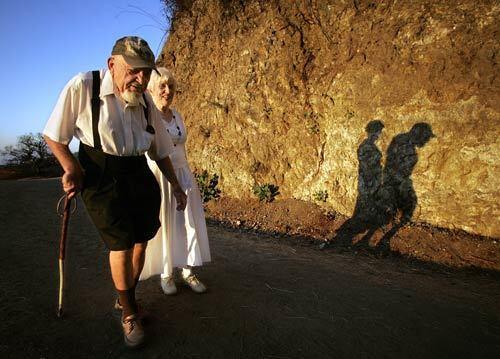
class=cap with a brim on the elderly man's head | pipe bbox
[111,36,156,70]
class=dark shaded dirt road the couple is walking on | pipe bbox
[0,179,500,359]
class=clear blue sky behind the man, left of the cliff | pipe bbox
[0,0,168,155]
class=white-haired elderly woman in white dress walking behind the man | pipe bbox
[141,67,210,295]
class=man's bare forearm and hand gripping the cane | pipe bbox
[43,136,83,198]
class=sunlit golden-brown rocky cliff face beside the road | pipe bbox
[160,0,500,237]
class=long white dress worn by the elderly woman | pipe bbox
[140,110,210,280]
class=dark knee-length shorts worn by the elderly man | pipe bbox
[79,146,161,251]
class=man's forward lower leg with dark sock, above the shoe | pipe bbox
[109,249,137,318]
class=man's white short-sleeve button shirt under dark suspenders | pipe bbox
[43,70,173,161]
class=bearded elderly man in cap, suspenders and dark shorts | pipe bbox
[44,36,186,347]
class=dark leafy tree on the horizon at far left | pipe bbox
[1,133,56,175]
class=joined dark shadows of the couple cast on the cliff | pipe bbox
[333,120,435,246]
